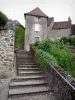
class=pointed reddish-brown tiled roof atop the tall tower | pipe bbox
[25,7,48,17]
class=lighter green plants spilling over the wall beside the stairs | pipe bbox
[35,50,57,71]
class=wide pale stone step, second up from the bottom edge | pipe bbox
[9,86,50,97]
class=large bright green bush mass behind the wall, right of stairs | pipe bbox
[33,39,75,76]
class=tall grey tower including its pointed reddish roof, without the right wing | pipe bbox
[24,7,48,51]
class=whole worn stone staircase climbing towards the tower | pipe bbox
[8,50,55,100]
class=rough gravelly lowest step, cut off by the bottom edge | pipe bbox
[8,91,56,100]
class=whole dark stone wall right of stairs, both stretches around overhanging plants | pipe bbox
[30,45,75,100]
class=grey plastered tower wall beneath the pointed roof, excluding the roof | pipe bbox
[24,15,47,51]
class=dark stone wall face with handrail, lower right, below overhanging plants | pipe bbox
[46,64,75,100]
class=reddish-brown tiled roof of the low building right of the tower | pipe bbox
[52,21,71,29]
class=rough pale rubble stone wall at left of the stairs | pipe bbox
[0,30,14,79]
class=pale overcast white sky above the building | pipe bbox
[0,0,75,26]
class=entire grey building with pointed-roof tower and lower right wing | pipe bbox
[24,7,71,51]
